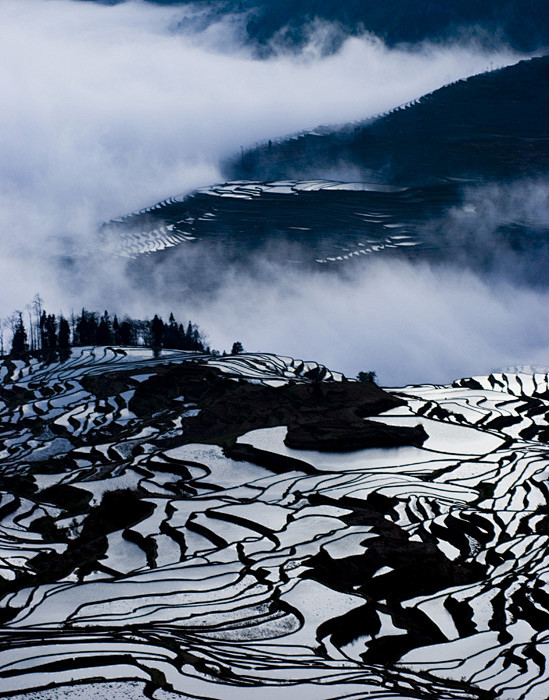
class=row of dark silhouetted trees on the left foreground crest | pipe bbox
[6,295,213,358]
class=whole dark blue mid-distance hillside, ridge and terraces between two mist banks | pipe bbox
[96,57,549,294]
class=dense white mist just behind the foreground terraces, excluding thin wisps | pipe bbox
[183,260,549,386]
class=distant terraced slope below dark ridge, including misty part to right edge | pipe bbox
[101,175,549,297]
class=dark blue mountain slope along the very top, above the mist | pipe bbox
[79,0,549,51]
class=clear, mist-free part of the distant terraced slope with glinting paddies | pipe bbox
[101,180,460,264]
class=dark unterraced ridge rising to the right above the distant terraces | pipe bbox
[225,56,549,185]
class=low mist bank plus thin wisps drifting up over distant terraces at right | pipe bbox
[112,174,549,386]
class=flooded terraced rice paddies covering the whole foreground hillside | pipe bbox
[0,348,549,700]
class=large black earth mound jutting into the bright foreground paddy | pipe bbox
[125,364,416,451]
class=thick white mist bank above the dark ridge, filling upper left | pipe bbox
[0,0,519,302]
